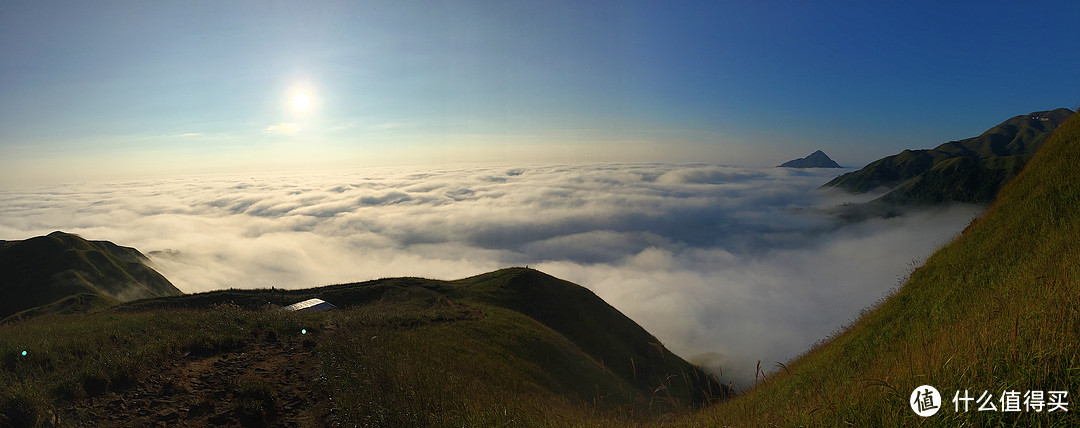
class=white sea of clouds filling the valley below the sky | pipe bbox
[0,164,982,386]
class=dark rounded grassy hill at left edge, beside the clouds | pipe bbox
[0,231,181,319]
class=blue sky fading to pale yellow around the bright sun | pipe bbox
[0,1,1080,184]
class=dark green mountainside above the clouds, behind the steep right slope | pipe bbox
[822,108,1072,204]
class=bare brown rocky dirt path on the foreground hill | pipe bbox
[58,336,325,427]
